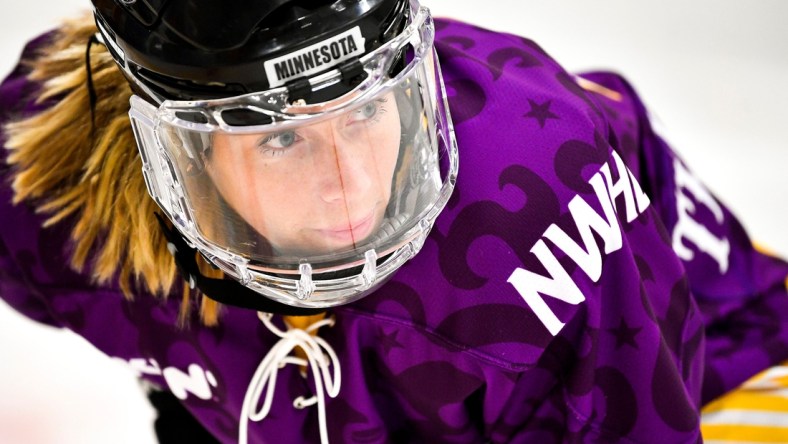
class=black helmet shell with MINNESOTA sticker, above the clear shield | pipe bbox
[93,0,409,102]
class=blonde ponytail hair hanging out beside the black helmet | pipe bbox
[5,15,220,325]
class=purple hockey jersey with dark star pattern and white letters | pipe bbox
[0,20,788,443]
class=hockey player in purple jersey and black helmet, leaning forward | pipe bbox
[0,0,788,443]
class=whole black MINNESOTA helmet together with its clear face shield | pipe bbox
[93,0,457,313]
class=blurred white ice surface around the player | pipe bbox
[0,0,788,444]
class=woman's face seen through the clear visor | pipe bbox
[207,93,400,255]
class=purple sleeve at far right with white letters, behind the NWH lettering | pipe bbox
[586,73,788,404]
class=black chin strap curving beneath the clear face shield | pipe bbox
[155,213,326,316]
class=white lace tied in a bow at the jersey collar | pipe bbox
[238,313,342,444]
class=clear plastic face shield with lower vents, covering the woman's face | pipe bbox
[130,8,457,308]
